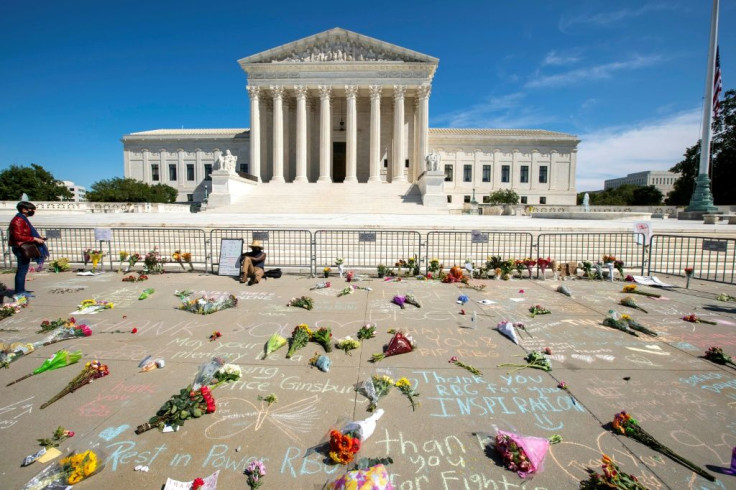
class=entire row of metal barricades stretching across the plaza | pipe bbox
[0,227,736,284]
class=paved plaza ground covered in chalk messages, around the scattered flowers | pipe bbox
[0,258,736,490]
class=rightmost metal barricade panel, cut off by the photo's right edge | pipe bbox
[648,235,736,284]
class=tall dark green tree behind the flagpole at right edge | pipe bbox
[667,90,736,206]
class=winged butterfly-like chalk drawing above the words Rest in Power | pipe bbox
[205,395,320,443]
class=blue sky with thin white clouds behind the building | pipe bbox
[0,0,736,191]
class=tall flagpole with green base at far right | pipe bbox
[685,0,719,219]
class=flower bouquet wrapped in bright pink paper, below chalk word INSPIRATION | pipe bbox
[494,430,562,478]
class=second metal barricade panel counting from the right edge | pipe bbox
[537,233,646,275]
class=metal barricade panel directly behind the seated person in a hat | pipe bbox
[210,228,312,273]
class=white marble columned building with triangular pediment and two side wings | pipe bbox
[122,28,579,208]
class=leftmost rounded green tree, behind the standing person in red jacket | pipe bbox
[0,163,73,201]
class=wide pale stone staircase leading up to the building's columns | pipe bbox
[206,182,448,215]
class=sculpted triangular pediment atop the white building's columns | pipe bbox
[238,27,439,66]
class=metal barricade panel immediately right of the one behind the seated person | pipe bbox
[313,230,422,273]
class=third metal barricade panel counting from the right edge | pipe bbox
[425,231,534,269]
